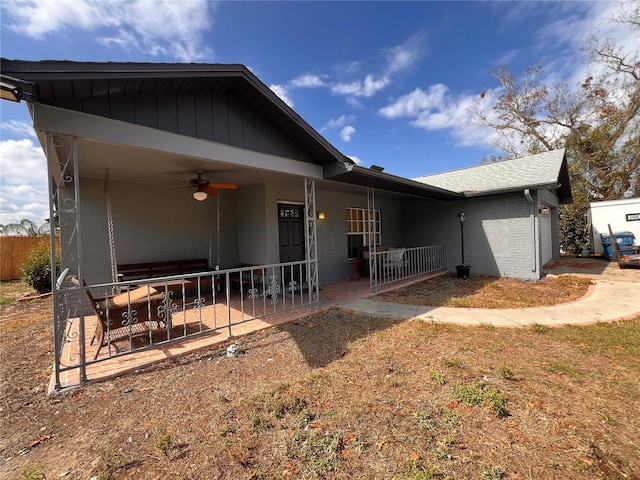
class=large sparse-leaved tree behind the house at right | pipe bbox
[472,2,640,253]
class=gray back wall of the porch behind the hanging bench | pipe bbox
[80,178,238,283]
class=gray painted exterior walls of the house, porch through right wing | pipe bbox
[71,178,557,284]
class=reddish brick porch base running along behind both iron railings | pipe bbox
[49,270,444,393]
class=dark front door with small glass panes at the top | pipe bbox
[278,203,306,288]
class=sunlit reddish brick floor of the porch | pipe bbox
[49,276,400,393]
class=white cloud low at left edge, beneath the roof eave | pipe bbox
[0,139,49,225]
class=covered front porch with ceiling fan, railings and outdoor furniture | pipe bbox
[41,129,447,390]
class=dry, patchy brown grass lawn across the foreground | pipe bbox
[0,279,640,480]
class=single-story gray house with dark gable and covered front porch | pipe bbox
[1,59,571,388]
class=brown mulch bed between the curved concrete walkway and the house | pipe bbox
[373,274,591,308]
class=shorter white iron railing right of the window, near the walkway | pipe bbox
[370,245,447,293]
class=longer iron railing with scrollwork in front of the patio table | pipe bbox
[53,261,319,388]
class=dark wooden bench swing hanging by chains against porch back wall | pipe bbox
[118,258,222,295]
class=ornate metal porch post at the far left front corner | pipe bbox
[45,132,87,390]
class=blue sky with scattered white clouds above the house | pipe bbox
[0,0,640,225]
